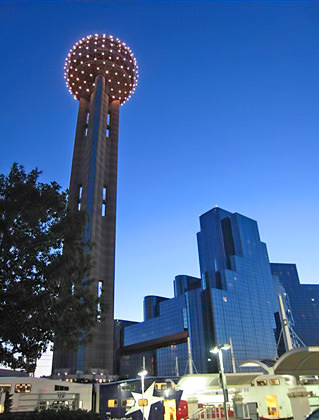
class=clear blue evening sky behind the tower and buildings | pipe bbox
[0,0,319,328]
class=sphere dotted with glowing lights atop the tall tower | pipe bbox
[64,34,138,104]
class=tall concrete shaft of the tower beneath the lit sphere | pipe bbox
[53,75,120,374]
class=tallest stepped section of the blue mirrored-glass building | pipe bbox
[197,208,278,371]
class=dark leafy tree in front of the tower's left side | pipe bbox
[0,164,97,371]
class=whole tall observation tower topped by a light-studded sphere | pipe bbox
[53,34,138,375]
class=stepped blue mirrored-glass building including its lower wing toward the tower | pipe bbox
[120,207,278,377]
